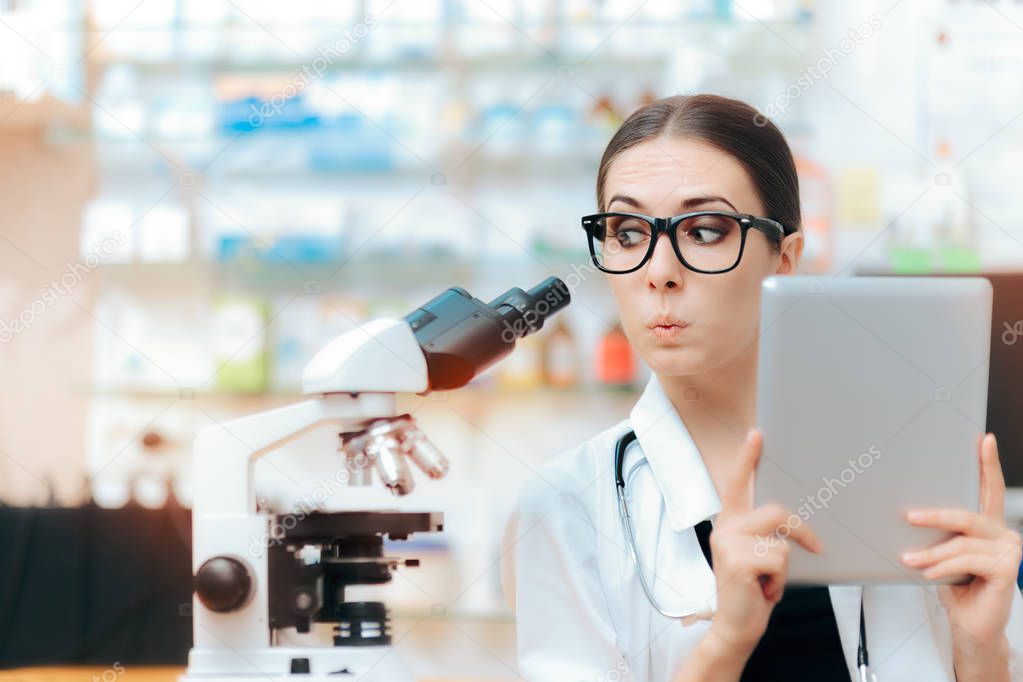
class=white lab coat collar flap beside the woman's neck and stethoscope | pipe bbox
[630,374,721,533]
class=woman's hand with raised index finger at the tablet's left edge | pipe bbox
[710,429,821,658]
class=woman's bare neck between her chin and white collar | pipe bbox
[658,343,758,474]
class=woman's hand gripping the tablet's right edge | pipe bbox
[902,434,1021,670]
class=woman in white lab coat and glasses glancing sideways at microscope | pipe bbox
[504,95,1023,682]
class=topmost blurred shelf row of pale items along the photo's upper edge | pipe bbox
[74,0,813,67]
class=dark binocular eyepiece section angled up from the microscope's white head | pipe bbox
[404,277,572,391]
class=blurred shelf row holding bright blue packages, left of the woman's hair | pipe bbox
[72,64,642,179]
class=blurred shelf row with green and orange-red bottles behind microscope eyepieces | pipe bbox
[88,275,644,403]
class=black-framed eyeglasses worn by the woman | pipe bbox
[582,211,795,275]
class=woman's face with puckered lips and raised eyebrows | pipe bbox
[603,132,802,376]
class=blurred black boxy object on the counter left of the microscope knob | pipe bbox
[0,505,192,668]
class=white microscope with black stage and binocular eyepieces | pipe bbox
[181,277,570,682]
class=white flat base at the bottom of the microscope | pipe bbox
[178,646,415,682]
